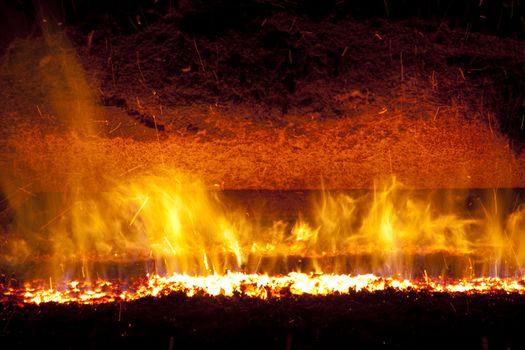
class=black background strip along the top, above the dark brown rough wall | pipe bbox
[0,0,525,49]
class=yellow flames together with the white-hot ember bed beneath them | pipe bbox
[0,172,525,303]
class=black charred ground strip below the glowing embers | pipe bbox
[0,290,525,349]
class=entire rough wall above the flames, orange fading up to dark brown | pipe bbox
[0,5,525,191]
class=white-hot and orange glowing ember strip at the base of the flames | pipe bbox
[3,273,525,304]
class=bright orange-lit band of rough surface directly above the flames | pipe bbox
[2,102,525,191]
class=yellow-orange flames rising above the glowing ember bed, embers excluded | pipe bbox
[1,175,525,281]
